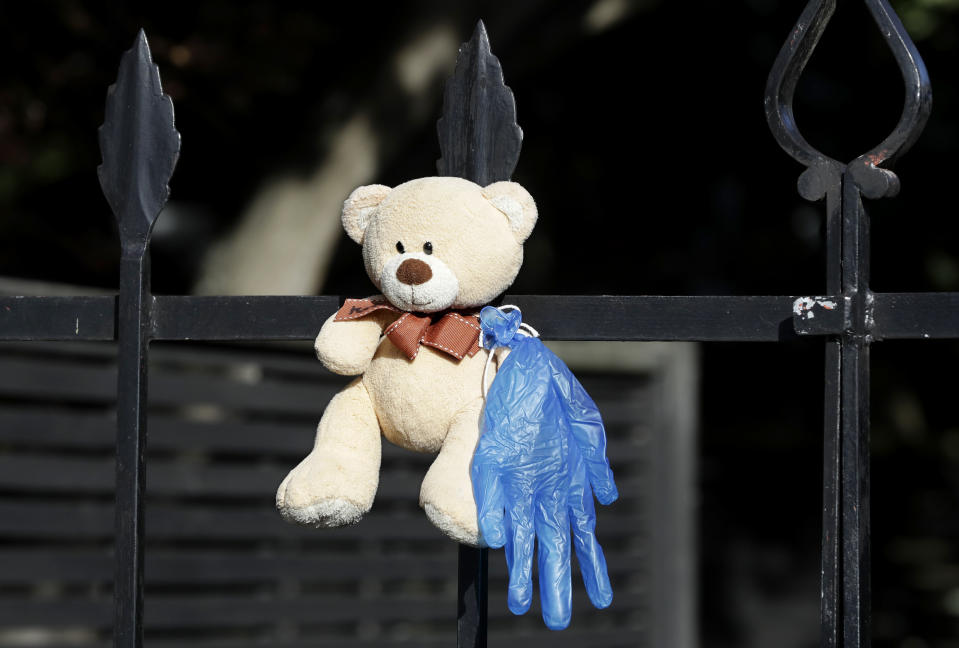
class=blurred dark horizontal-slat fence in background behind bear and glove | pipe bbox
[0,336,695,648]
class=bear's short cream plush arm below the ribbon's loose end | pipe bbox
[313,311,396,376]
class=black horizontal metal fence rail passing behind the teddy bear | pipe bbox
[0,293,959,342]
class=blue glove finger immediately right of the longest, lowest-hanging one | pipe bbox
[569,469,613,608]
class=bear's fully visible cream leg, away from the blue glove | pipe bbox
[276,378,382,527]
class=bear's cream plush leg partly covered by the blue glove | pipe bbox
[420,399,486,547]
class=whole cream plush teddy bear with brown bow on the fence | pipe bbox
[276,177,537,546]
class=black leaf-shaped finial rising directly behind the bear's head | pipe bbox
[436,20,523,185]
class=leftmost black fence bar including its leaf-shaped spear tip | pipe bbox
[97,30,180,648]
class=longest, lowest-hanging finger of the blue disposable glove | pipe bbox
[535,493,573,630]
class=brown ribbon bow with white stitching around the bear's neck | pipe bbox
[333,297,480,360]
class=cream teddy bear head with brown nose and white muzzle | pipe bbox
[343,177,537,313]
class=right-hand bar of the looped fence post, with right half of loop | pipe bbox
[840,0,932,636]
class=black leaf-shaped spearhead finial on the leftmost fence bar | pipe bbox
[97,29,180,249]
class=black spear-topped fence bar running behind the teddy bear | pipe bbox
[436,21,523,648]
